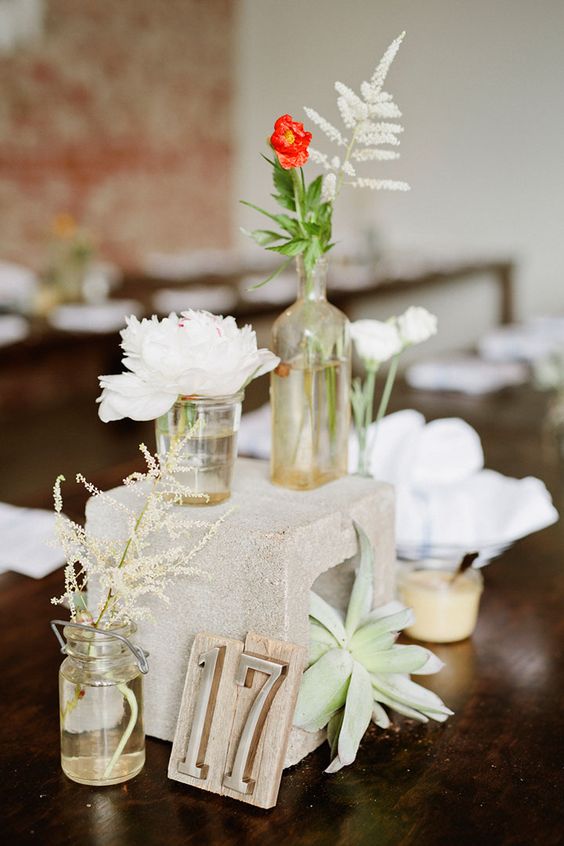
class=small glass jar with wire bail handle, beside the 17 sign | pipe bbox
[51,620,148,786]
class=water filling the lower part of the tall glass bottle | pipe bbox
[270,359,350,490]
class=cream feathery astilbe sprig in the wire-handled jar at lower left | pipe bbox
[51,438,233,628]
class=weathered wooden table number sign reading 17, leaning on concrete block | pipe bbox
[168,632,306,808]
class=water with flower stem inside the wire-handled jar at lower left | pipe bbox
[60,672,145,785]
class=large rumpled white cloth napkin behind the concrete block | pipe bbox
[239,405,558,564]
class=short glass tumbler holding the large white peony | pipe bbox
[156,391,244,505]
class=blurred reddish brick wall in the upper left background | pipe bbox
[0,0,234,268]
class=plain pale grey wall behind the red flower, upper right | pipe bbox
[235,0,564,320]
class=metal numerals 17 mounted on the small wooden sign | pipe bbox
[178,646,288,793]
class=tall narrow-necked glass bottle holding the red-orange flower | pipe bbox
[270,256,351,490]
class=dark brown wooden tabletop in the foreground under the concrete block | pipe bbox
[0,389,564,846]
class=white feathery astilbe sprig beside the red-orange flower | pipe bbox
[305,33,409,201]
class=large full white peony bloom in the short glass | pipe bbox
[98,311,280,423]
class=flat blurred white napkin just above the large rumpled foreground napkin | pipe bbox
[405,355,528,396]
